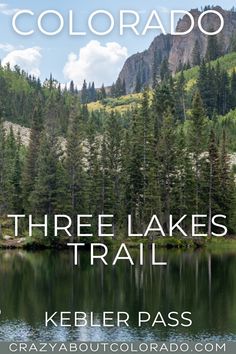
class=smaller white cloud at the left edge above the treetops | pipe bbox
[2,47,42,77]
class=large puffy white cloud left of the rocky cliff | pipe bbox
[63,40,128,87]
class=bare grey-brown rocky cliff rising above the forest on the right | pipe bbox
[119,6,236,93]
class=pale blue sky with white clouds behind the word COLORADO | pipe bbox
[0,0,235,88]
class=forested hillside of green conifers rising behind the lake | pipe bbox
[0,53,236,243]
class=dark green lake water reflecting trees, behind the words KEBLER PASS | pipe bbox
[0,251,236,341]
